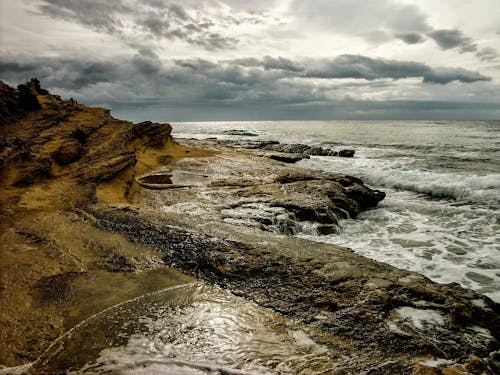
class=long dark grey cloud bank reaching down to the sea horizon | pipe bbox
[0,53,498,120]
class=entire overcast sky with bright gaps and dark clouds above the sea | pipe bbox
[0,0,500,121]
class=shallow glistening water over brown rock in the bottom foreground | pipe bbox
[31,283,338,374]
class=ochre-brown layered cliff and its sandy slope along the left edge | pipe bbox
[0,81,204,365]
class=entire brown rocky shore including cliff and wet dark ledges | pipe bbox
[0,81,500,374]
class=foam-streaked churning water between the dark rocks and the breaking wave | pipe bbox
[300,190,500,301]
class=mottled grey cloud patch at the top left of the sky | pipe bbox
[34,0,247,50]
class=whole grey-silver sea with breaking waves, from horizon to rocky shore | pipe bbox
[172,121,500,302]
